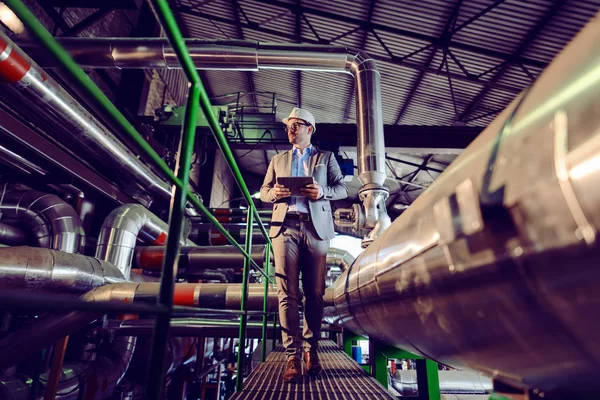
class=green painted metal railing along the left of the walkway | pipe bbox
[5,0,273,399]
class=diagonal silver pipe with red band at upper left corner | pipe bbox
[0,32,171,208]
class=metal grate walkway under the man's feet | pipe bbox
[231,340,396,400]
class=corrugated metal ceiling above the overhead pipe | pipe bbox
[173,0,600,126]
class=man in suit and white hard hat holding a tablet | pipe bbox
[260,108,348,382]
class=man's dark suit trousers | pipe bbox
[272,217,329,356]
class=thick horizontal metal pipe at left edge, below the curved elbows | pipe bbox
[0,247,125,293]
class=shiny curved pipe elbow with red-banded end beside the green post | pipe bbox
[96,204,194,279]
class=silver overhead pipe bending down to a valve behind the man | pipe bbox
[22,38,391,244]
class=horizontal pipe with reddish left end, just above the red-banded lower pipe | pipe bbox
[134,245,265,275]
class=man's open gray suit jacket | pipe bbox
[260,149,348,240]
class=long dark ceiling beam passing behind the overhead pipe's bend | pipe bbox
[173,6,524,94]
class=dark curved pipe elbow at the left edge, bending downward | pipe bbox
[0,190,85,253]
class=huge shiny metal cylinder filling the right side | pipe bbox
[328,12,600,398]
